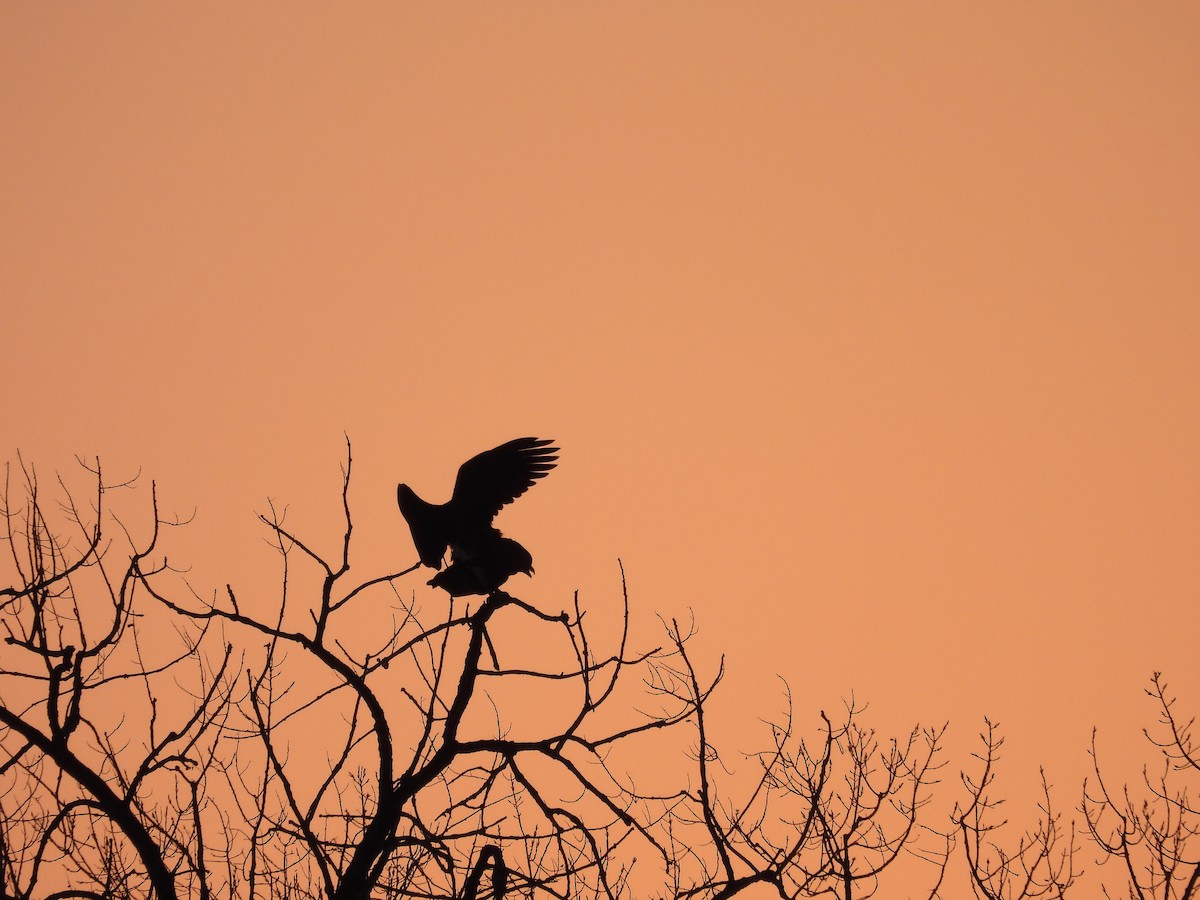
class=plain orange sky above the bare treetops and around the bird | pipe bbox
[0,0,1200,868]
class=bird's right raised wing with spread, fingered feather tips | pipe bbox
[450,438,558,524]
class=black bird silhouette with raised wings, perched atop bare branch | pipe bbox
[396,438,558,596]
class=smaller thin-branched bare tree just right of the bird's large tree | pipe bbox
[656,622,944,900]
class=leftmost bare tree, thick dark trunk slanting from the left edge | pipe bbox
[0,463,232,898]
